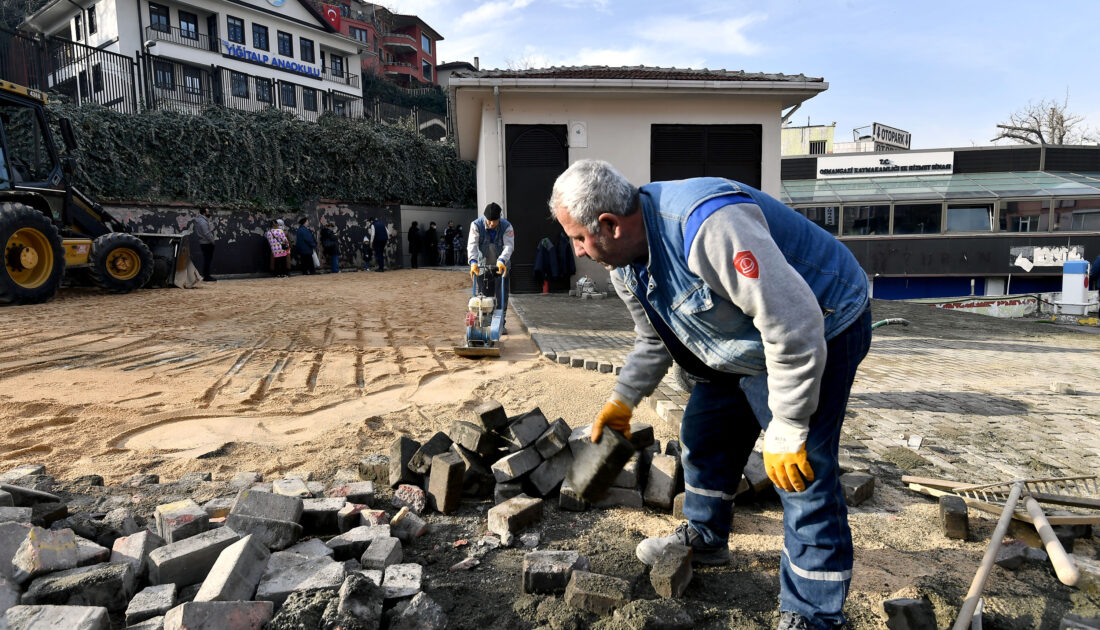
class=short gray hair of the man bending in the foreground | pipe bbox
[550,159,638,234]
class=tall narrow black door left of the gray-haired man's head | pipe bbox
[504,124,573,294]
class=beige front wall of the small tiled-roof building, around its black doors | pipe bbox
[477,90,781,281]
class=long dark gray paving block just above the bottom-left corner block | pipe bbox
[22,562,134,610]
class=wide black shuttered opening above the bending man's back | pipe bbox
[649,124,762,188]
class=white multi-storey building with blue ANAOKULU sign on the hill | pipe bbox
[21,0,362,120]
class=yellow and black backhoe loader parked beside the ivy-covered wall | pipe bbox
[0,80,198,305]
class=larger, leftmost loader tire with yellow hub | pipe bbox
[0,202,65,305]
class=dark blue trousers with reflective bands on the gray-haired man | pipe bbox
[680,311,871,629]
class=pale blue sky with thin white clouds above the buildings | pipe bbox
[387,0,1100,148]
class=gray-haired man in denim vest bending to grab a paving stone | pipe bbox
[550,159,871,629]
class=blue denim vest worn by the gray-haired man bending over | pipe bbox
[614,177,869,374]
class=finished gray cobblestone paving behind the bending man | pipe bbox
[510,294,1100,483]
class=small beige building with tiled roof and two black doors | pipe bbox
[448,66,828,291]
